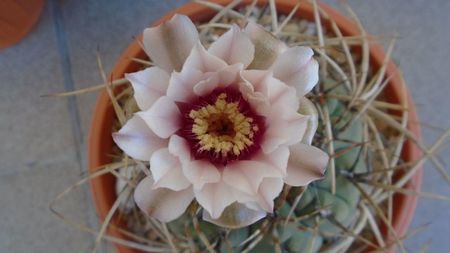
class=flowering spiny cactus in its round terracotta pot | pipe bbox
[49,0,432,253]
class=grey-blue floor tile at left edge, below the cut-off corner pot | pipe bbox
[0,2,79,175]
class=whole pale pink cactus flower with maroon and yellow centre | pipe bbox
[113,15,328,227]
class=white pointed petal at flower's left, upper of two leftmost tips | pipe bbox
[125,67,169,111]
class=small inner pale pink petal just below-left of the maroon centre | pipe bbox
[183,160,220,190]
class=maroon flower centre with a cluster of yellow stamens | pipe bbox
[179,90,264,165]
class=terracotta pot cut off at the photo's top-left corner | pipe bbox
[0,0,44,49]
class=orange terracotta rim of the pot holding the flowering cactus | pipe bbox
[88,0,422,253]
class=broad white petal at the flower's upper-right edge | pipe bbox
[271,47,319,97]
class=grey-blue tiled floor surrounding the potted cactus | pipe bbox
[0,0,450,253]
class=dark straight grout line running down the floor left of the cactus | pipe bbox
[48,0,83,172]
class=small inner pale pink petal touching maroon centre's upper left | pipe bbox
[167,68,205,103]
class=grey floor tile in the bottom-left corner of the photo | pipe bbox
[0,159,93,253]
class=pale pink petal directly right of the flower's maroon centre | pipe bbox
[261,111,308,154]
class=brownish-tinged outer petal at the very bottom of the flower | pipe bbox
[203,203,266,229]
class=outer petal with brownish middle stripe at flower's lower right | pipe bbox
[284,143,329,186]
